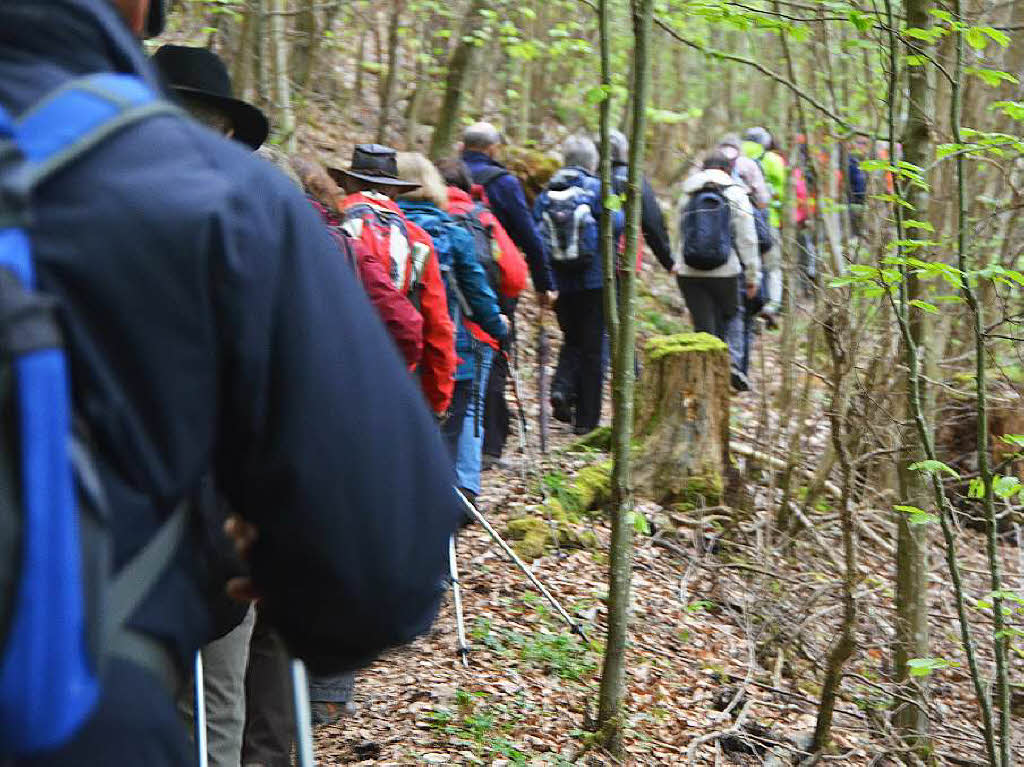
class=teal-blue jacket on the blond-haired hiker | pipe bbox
[398,200,508,381]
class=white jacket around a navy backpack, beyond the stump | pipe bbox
[676,170,761,285]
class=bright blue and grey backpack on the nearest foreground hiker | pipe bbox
[0,74,188,761]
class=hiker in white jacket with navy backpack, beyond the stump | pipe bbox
[675,150,761,391]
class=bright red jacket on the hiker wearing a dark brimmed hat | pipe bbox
[338,193,457,414]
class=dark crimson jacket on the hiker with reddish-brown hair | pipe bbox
[309,198,423,370]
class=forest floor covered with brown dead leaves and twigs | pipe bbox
[316,256,1024,765]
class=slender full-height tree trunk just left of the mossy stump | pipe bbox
[597,0,654,758]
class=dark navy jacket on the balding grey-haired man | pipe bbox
[462,152,554,293]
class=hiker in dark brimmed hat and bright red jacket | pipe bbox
[328,143,458,420]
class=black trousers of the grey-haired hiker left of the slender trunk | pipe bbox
[551,288,604,431]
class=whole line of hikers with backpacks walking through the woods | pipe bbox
[0,0,813,767]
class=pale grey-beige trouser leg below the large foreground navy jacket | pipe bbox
[178,606,256,767]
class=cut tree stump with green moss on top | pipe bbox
[633,333,730,506]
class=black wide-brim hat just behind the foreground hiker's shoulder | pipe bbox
[153,45,270,150]
